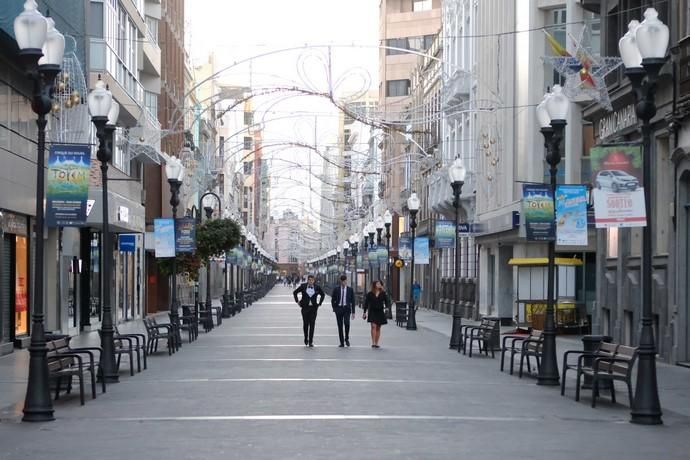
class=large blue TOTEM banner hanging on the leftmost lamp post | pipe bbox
[46,144,91,227]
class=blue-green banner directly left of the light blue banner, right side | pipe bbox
[522,184,556,241]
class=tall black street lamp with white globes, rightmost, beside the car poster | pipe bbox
[618,8,669,425]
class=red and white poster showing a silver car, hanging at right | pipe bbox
[590,145,647,228]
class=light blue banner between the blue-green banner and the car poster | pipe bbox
[556,185,587,246]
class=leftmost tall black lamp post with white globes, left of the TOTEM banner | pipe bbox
[14,0,65,422]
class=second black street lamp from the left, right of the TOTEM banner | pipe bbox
[88,78,120,382]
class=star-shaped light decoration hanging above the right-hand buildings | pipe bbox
[542,26,623,111]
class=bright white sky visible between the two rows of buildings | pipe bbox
[185,0,379,227]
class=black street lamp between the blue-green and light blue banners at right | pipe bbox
[536,85,570,385]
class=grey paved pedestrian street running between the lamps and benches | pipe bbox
[0,287,690,460]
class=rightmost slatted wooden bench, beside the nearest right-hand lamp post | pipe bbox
[575,342,638,408]
